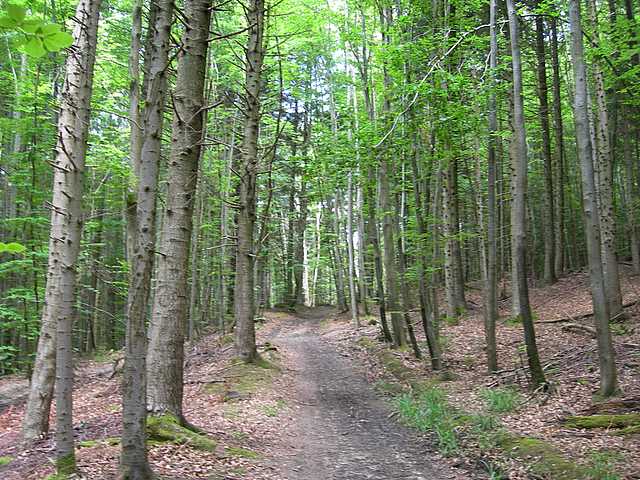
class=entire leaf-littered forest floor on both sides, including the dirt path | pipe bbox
[0,273,640,480]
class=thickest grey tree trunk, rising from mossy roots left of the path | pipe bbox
[147,0,212,423]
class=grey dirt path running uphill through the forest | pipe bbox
[273,309,464,480]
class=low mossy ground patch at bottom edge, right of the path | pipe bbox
[499,434,588,480]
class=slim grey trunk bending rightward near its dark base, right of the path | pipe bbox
[507,0,546,387]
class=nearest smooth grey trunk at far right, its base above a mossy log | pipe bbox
[569,0,618,396]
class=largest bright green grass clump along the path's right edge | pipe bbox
[396,386,460,455]
